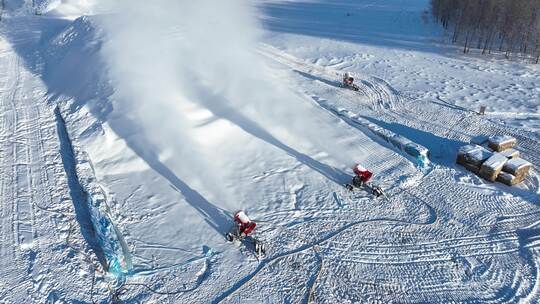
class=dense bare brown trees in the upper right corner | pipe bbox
[431,0,540,63]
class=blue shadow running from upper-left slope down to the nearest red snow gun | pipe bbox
[3,16,230,234]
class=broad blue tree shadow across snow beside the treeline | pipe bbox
[258,0,441,53]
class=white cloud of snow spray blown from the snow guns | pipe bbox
[97,0,353,203]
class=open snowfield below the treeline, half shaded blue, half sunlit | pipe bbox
[260,0,540,133]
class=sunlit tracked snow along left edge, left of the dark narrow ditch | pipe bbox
[0,1,118,303]
